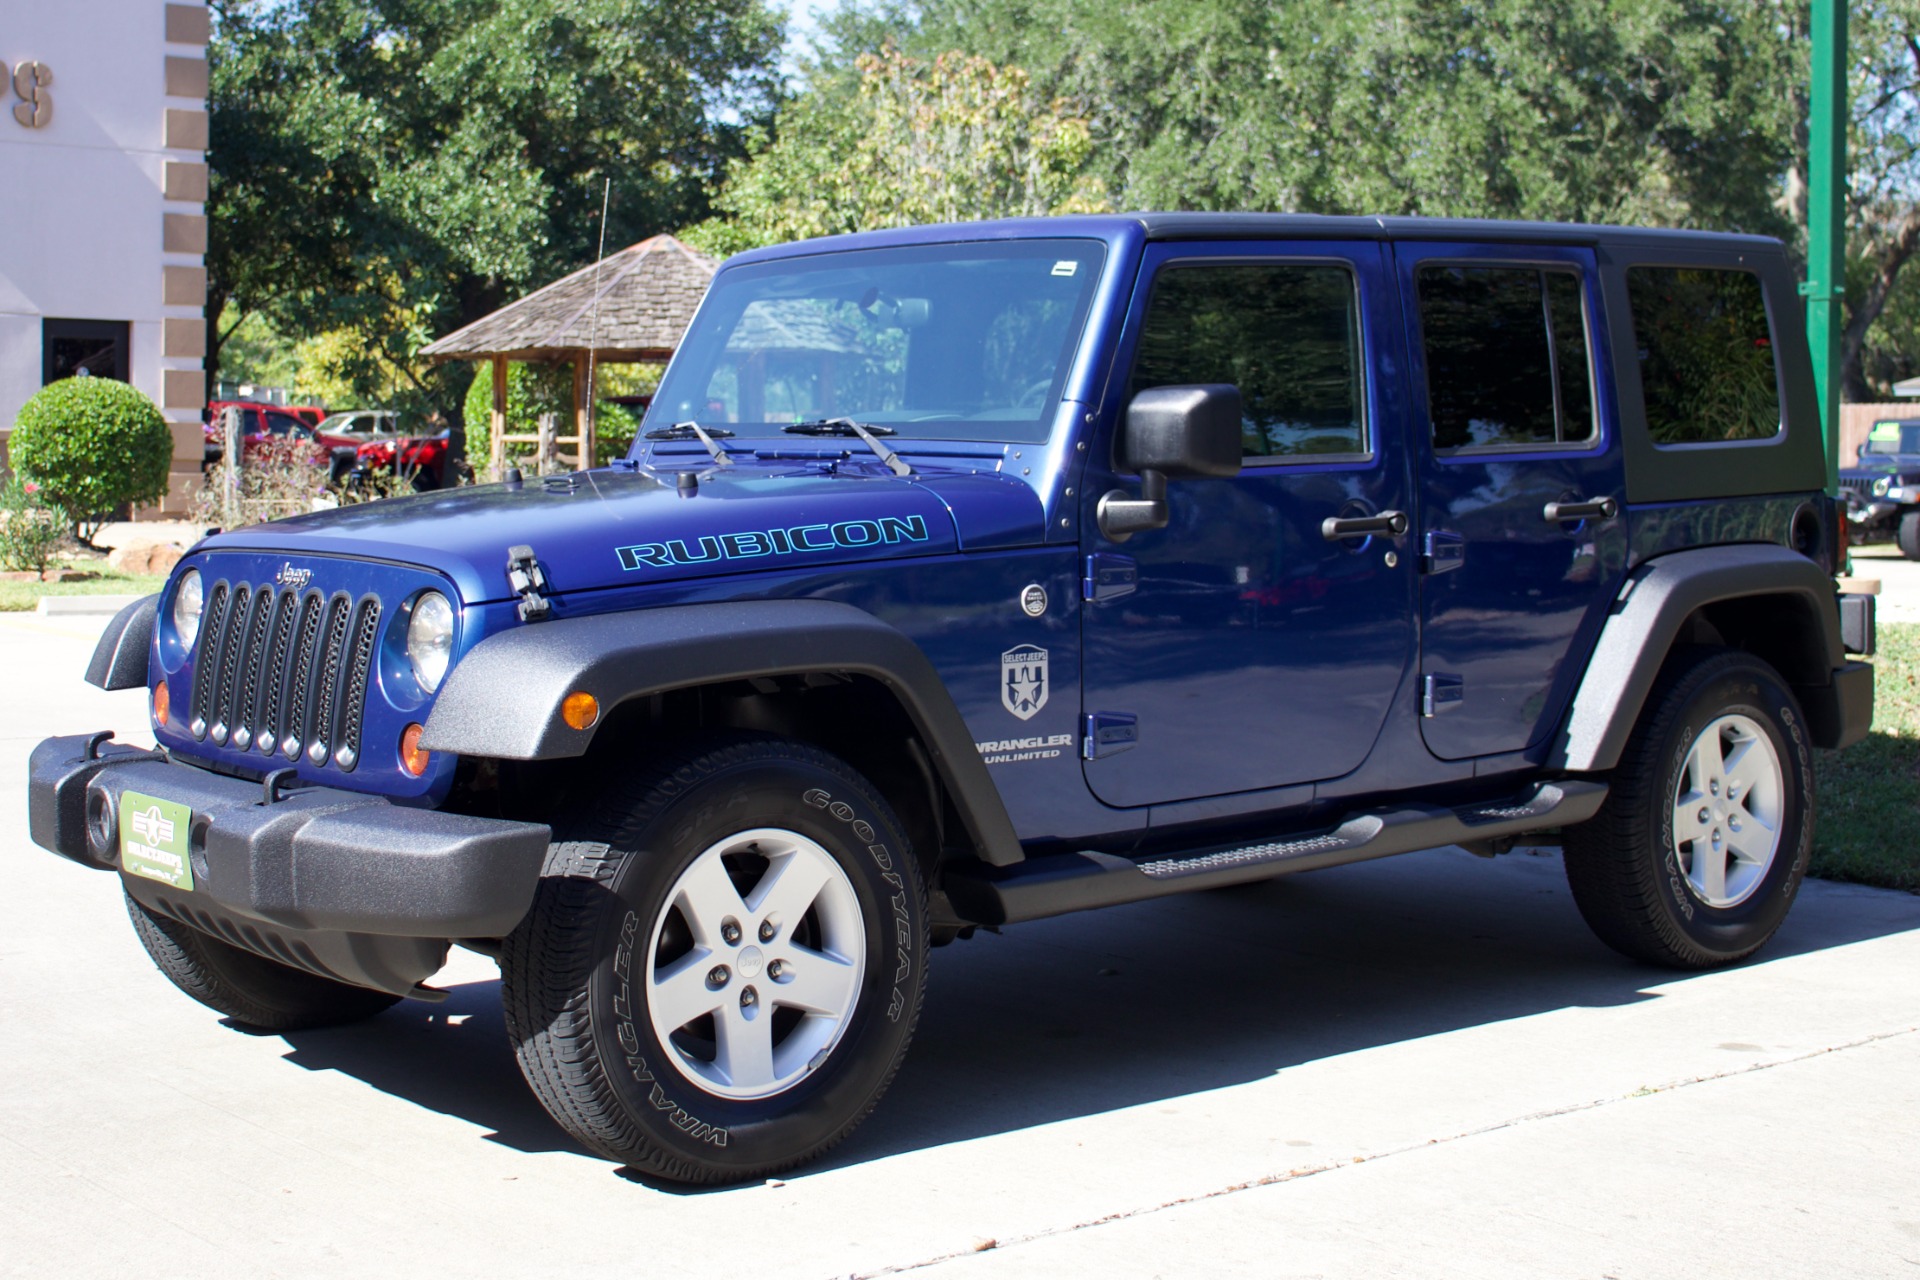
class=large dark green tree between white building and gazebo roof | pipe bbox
[207,0,781,435]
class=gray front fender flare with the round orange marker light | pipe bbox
[420,601,1025,865]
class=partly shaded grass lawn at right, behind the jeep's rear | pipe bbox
[1811,624,1920,892]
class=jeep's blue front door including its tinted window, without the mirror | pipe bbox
[1083,242,1415,806]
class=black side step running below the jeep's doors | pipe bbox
[945,779,1607,925]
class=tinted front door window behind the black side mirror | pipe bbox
[1127,263,1367,459]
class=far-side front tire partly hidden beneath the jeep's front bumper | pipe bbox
[127,894,399,1031]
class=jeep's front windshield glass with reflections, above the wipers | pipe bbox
[643,240,1106,441]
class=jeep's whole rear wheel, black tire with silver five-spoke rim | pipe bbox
[1565,649,1814,969]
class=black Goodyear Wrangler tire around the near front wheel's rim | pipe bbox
[501,735,927,1184]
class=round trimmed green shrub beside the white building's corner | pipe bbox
[8,378,173,543]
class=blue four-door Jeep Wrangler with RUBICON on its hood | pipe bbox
[31,215,1872,1182]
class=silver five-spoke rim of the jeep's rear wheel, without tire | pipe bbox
[1672,716,1786,908]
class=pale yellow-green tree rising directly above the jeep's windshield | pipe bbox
[689,48,1108,253]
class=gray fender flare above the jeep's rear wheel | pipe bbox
[1548,543,1870,771]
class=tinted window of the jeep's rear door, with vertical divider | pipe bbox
[1415,263,1596,449]
